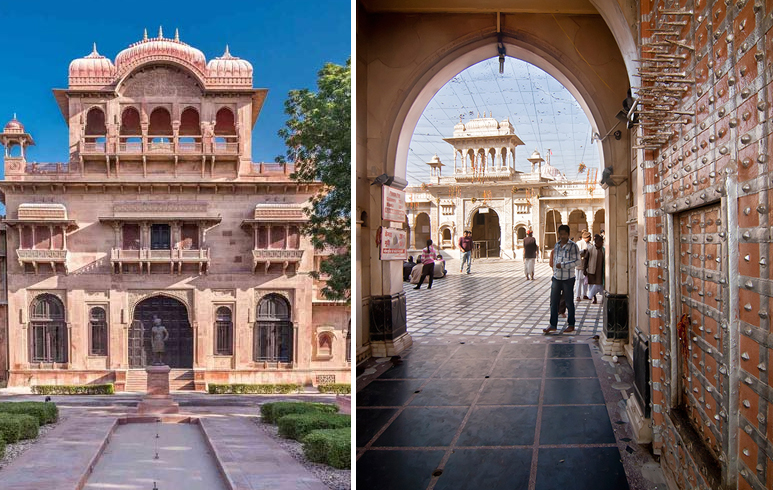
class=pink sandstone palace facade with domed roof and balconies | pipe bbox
[0,31,350,390]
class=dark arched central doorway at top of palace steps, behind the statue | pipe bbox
[129,296,193,369]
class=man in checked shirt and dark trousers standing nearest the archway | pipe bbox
[543,225,580,334]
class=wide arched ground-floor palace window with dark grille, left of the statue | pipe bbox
[30,294,67,362]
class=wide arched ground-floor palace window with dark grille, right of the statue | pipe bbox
[254,294,293,362]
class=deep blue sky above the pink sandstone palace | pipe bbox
[0,0,351,167]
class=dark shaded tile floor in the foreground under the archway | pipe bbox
[357,340,629,490]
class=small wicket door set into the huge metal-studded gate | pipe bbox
[675,204,730,462]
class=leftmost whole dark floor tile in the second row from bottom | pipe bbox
[373,407,468,447]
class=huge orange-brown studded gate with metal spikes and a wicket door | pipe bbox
[640,0,773,490]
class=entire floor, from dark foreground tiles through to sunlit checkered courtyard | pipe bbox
[356,260,666,490]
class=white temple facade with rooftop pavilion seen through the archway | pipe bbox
[406,117,604,259]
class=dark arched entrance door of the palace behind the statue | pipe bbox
[130,296,193,368]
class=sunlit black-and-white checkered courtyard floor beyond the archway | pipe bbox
[403,259,604,339]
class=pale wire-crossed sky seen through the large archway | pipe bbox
[407,57,600,184]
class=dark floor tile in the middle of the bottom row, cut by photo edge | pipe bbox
[432,449,532,490]
